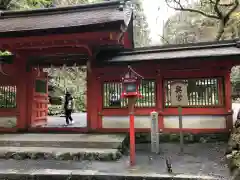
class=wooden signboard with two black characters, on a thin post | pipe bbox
[171,81,188,106]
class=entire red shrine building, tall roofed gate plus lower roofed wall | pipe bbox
[0,1,240,133]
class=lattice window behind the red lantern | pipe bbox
[103,80,156,108]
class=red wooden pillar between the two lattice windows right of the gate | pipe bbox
[156,71,164,132]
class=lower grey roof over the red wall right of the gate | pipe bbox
[105,40,240,63]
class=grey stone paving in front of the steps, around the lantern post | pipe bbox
[0,143,230,180]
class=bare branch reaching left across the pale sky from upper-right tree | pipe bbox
[165,0,220,19]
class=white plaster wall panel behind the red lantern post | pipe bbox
[102,116,151,128]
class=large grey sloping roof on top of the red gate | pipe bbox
[0,0,132,37]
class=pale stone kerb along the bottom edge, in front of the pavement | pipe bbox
[0,168,219,180]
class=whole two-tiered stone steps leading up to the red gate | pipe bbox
[0,134,126,161]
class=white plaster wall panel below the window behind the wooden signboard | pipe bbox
[163,115,226,129]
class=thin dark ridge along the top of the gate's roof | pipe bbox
[0,0,126,19]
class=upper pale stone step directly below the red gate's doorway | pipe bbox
[0,134,126,149]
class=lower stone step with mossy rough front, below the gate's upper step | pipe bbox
[0,146,122,161]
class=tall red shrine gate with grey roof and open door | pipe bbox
[0,1,133,131]
